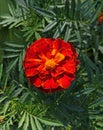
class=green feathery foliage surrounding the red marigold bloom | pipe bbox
[0,0,103,130]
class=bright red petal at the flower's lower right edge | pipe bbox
[57,74,74,89]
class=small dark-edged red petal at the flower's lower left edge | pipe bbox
[29,75,42,87]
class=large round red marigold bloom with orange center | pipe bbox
[23,38,79,93]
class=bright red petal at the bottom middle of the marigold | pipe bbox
[43,78,58,89]
